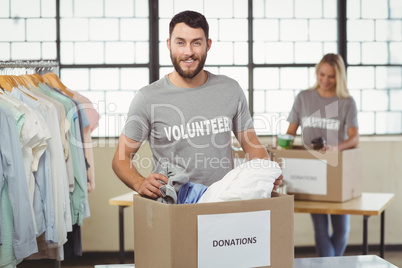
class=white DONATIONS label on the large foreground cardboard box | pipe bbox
[198,210,271,268]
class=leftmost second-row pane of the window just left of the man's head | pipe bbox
[60,19,89,41]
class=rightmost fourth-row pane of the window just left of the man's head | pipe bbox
[120,68,149,90]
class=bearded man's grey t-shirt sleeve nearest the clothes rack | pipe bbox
[122,91,150,142]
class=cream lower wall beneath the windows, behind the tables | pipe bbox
[82,136,402,251]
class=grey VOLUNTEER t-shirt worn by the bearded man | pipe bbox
[123,72,253,186]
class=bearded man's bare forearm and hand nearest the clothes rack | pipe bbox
[112,134,168,198]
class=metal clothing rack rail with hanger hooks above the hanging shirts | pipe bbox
[0,60,61,268]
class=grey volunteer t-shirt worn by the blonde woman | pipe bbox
[288,90,358,148]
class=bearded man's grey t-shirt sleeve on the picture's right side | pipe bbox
[233,84,253,133]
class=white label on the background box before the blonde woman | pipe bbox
[282,158,327,195]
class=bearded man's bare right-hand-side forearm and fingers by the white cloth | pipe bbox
[234,127,283,191]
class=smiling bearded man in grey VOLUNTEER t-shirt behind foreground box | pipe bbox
[112,11,282,198]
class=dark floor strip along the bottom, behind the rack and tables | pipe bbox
[17,250,402,268]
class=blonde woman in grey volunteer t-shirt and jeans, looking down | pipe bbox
[287,53,359,257]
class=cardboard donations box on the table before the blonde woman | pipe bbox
[268,146,362,202]
